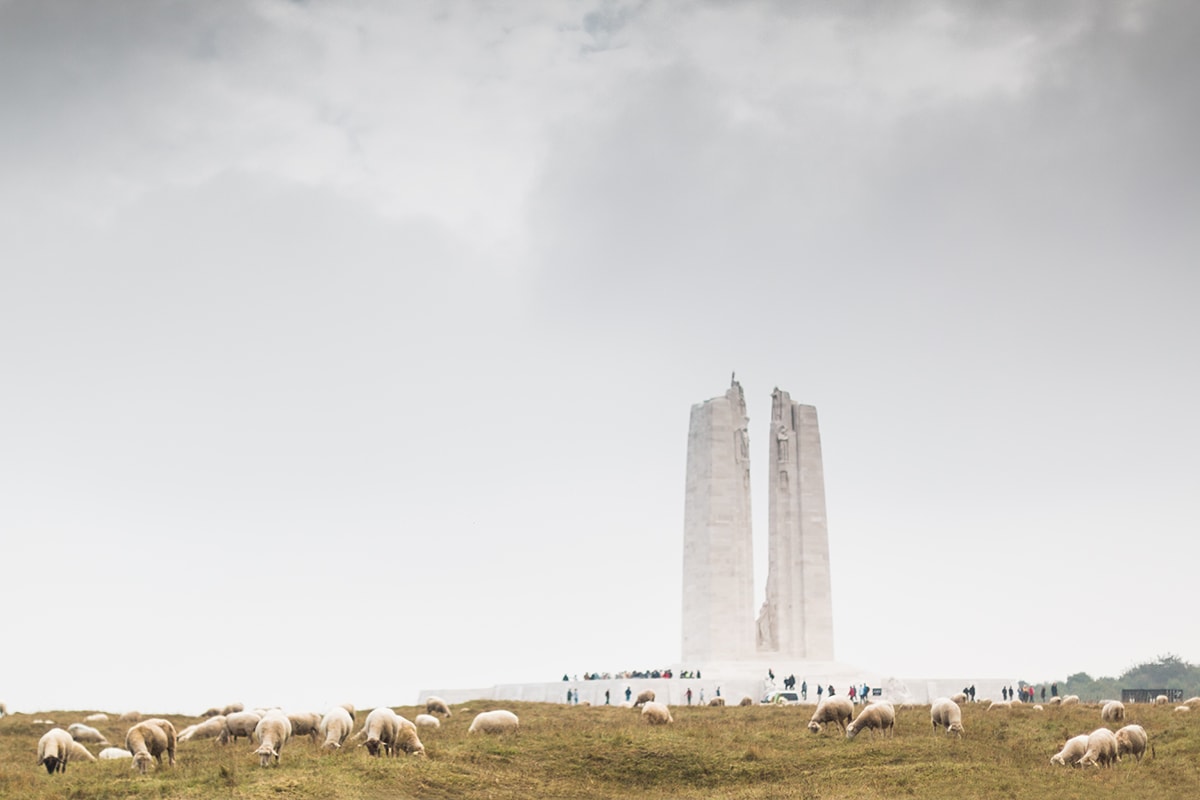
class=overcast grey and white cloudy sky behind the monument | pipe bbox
[0,0,1200,712]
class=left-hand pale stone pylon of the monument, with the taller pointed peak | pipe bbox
[682,379,755,666]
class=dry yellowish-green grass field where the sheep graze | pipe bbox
[0,700,1200,800]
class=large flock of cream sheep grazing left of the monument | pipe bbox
[35,697,518,775]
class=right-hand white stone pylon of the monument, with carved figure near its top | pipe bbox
[757,387,834,661]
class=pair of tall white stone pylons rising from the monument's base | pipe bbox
[682,380,834,666]
